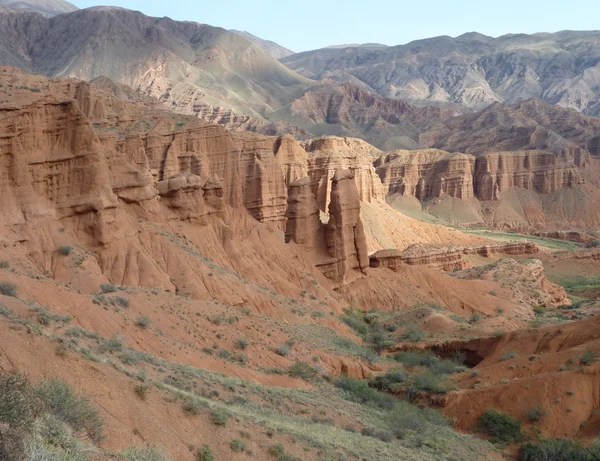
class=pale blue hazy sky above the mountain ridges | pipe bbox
[71,0,600,51]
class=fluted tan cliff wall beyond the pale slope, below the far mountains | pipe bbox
[375,148,589,201]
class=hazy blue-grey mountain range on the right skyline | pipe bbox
[281,31,600,115]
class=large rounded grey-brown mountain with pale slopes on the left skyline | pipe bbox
[0,7,312,117]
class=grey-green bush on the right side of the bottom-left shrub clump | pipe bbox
[36,379,103,442]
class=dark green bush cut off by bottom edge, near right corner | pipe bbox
[519,439,600,461]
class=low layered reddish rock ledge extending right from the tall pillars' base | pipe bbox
[369,242,540,271]
